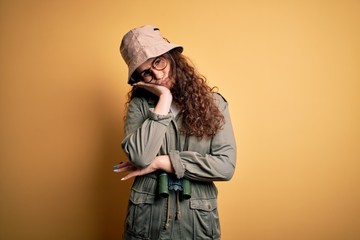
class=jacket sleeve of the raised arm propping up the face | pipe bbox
[121,98,172,168]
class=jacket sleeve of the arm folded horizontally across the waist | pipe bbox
[170,95,236,181]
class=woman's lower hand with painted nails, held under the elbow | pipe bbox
[114,155,174,180]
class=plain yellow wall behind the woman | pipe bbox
[0,0,360,240]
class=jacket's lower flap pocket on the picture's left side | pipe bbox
[126,189,155,239]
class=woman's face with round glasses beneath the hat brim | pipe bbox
[136,55,175,89]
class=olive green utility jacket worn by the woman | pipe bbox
[122,94,236,240]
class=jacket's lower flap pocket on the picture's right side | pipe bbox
[190,198,220,239]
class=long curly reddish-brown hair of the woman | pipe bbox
[127,49,225,138]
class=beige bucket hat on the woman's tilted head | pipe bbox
[120,25,183,84]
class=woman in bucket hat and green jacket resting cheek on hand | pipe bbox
[114,26,236,240]
